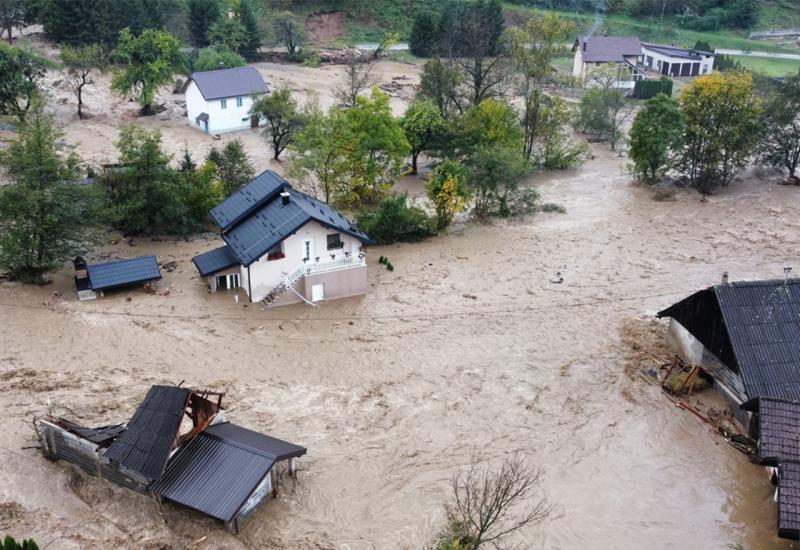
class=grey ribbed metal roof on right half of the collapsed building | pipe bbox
[151,423,306,521]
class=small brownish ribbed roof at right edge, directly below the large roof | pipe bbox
[758,397,800,466]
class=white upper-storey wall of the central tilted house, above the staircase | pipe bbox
[241,221,361,302]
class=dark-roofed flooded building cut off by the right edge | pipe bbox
[658,278,800,540]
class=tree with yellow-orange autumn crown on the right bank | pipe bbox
[678,73,762,192]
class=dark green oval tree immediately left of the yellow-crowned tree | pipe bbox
[628,94,685,183]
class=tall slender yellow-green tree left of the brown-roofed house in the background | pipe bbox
[509,13,575,160]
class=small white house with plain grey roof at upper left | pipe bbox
[184,67,269,134]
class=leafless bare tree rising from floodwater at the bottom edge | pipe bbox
[438,455,554,550]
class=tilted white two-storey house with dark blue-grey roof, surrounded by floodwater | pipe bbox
[192,170,372,305]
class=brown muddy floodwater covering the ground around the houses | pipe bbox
[0,32,800,549]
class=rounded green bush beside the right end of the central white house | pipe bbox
[356,194,436,245]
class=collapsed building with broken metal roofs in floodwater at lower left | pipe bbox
[34,386,306,533]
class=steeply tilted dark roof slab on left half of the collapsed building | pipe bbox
[105,386,189,480]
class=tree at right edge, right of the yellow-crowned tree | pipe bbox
[758,71,800,181]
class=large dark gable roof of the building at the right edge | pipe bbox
[658,279,800,401]
